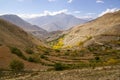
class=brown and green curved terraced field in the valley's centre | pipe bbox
[37,52,93,67]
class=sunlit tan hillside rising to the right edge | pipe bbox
[51,11,120,48]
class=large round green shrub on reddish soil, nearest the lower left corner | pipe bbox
[10,60,24,71]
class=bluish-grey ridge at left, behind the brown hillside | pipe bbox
[0,15,47,36]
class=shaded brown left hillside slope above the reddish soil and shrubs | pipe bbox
[0,19,44,48]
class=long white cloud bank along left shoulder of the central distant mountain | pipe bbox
[17,9,68,18]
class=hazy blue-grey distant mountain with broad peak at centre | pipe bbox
[27,13,88,32]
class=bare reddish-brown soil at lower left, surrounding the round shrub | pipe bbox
[0,46,46,70]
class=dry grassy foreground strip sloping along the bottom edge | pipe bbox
[6,66,120,80]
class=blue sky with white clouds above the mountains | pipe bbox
[0,0,120,18]
